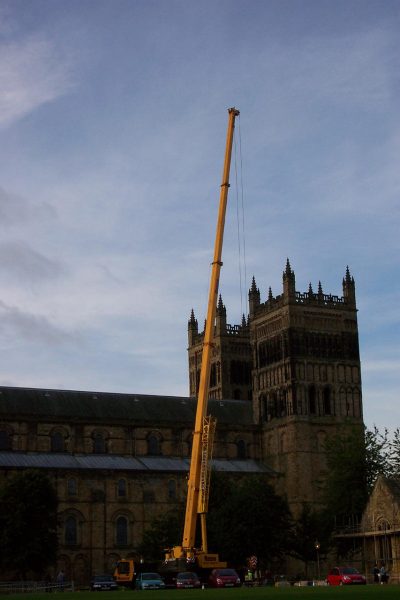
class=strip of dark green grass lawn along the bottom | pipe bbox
[4,585,400,600]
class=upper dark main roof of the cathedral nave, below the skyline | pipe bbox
[0,386,253,427]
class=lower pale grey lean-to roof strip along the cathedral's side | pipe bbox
[0,452,273,474]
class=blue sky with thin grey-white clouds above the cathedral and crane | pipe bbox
[0,0,400,430]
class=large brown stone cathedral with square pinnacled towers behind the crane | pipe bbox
[0,260,363,585]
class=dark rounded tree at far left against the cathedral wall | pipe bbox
[0,470,57,578]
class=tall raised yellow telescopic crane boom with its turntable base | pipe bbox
[165,108,240,568]
